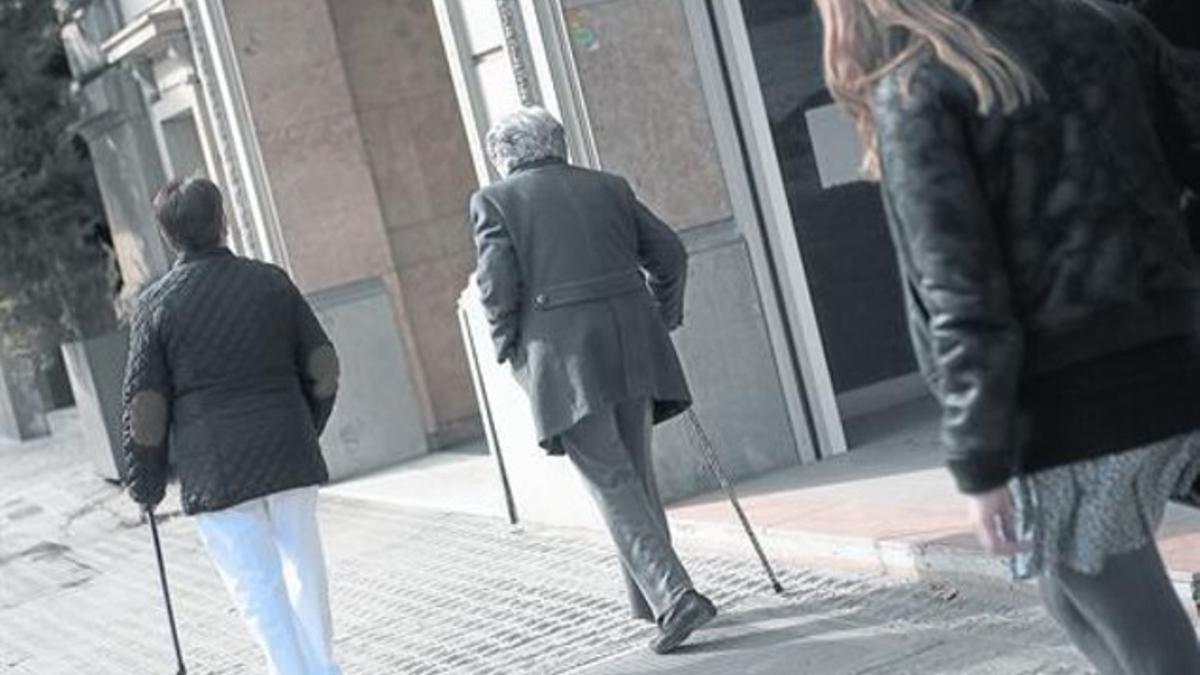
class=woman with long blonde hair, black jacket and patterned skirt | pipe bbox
[817,0,1200,675]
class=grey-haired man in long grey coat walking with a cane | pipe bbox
[470,108,716,653]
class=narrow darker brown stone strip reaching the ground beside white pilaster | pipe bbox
[329,0,479,444]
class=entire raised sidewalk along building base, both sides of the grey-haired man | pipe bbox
[331,396,1200,613]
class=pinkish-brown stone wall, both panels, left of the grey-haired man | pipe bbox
[218,0,479,446]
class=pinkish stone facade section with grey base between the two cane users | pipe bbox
[62,0,479,474]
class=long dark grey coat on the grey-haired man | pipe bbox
[470,160,691,454]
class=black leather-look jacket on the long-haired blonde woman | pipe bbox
[875,0,1200,492]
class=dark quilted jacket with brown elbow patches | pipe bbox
[125,249,337,514]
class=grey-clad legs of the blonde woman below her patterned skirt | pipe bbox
[1039,544,1200,675]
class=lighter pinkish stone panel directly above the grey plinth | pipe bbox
[224,0,398,291]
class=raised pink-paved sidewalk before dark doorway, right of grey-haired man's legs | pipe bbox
[671,398,1200,614]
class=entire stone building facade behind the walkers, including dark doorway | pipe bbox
[64,0,919,496]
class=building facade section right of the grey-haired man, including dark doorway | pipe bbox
[434,0,931,496]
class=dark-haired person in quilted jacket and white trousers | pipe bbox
[125,179,340,675]
